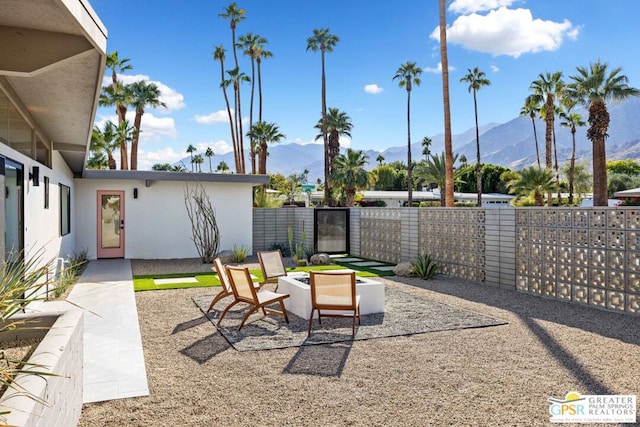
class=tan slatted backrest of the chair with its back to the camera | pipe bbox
[310,271,356,310]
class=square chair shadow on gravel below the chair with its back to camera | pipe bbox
[283,341,353,377]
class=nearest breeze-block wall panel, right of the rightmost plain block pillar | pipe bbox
[516,208,640,314]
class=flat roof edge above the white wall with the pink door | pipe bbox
[82,169,269,187]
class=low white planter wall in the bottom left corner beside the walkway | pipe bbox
[0,304,84,427]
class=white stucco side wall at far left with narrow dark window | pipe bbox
[0,150,75,261]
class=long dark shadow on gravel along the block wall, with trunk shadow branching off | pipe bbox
[393,276,640,394]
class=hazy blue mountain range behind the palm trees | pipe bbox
[181,98,640,183]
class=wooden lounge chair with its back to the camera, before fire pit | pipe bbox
[307,271,360,337]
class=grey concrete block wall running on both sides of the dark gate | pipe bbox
[254,207,640,315]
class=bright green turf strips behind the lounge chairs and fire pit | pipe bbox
[133,264,380,292]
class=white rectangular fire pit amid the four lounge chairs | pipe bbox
[278,270,384,319]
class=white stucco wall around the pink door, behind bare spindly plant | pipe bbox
[72,179,253,259]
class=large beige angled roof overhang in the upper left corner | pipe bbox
[0,0,107,173]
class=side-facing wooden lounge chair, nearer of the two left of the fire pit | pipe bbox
[218,266,289,330]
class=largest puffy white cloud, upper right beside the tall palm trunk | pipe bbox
[430,7,579,58]
